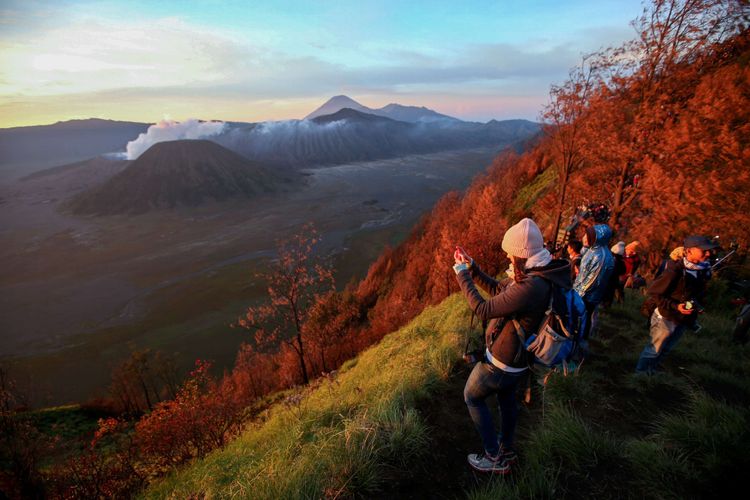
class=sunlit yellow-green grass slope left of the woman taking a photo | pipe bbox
[144,296,468,498]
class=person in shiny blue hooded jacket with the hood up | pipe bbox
[573,224,615,342]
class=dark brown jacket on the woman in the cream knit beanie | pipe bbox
[456,260,571,368]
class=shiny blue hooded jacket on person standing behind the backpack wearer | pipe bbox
[573,224,615,304]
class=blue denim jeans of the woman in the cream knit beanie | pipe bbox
[464,362,523,456]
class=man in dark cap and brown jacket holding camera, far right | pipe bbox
[635,236,716,374]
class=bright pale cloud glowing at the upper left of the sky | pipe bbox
[0,18,255,96]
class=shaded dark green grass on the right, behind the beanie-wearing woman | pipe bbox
[469,293,750,499]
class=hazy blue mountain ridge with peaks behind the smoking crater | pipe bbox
[217,108,540,169]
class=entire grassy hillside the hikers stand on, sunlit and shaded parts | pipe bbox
[144,286,750,498]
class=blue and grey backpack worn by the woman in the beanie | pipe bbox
[513,283,586,367]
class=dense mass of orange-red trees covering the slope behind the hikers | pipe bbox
[344,0,750,339]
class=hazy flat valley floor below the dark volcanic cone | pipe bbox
[0,148,506,404]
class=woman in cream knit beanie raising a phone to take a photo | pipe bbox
[453,218,571,474]
